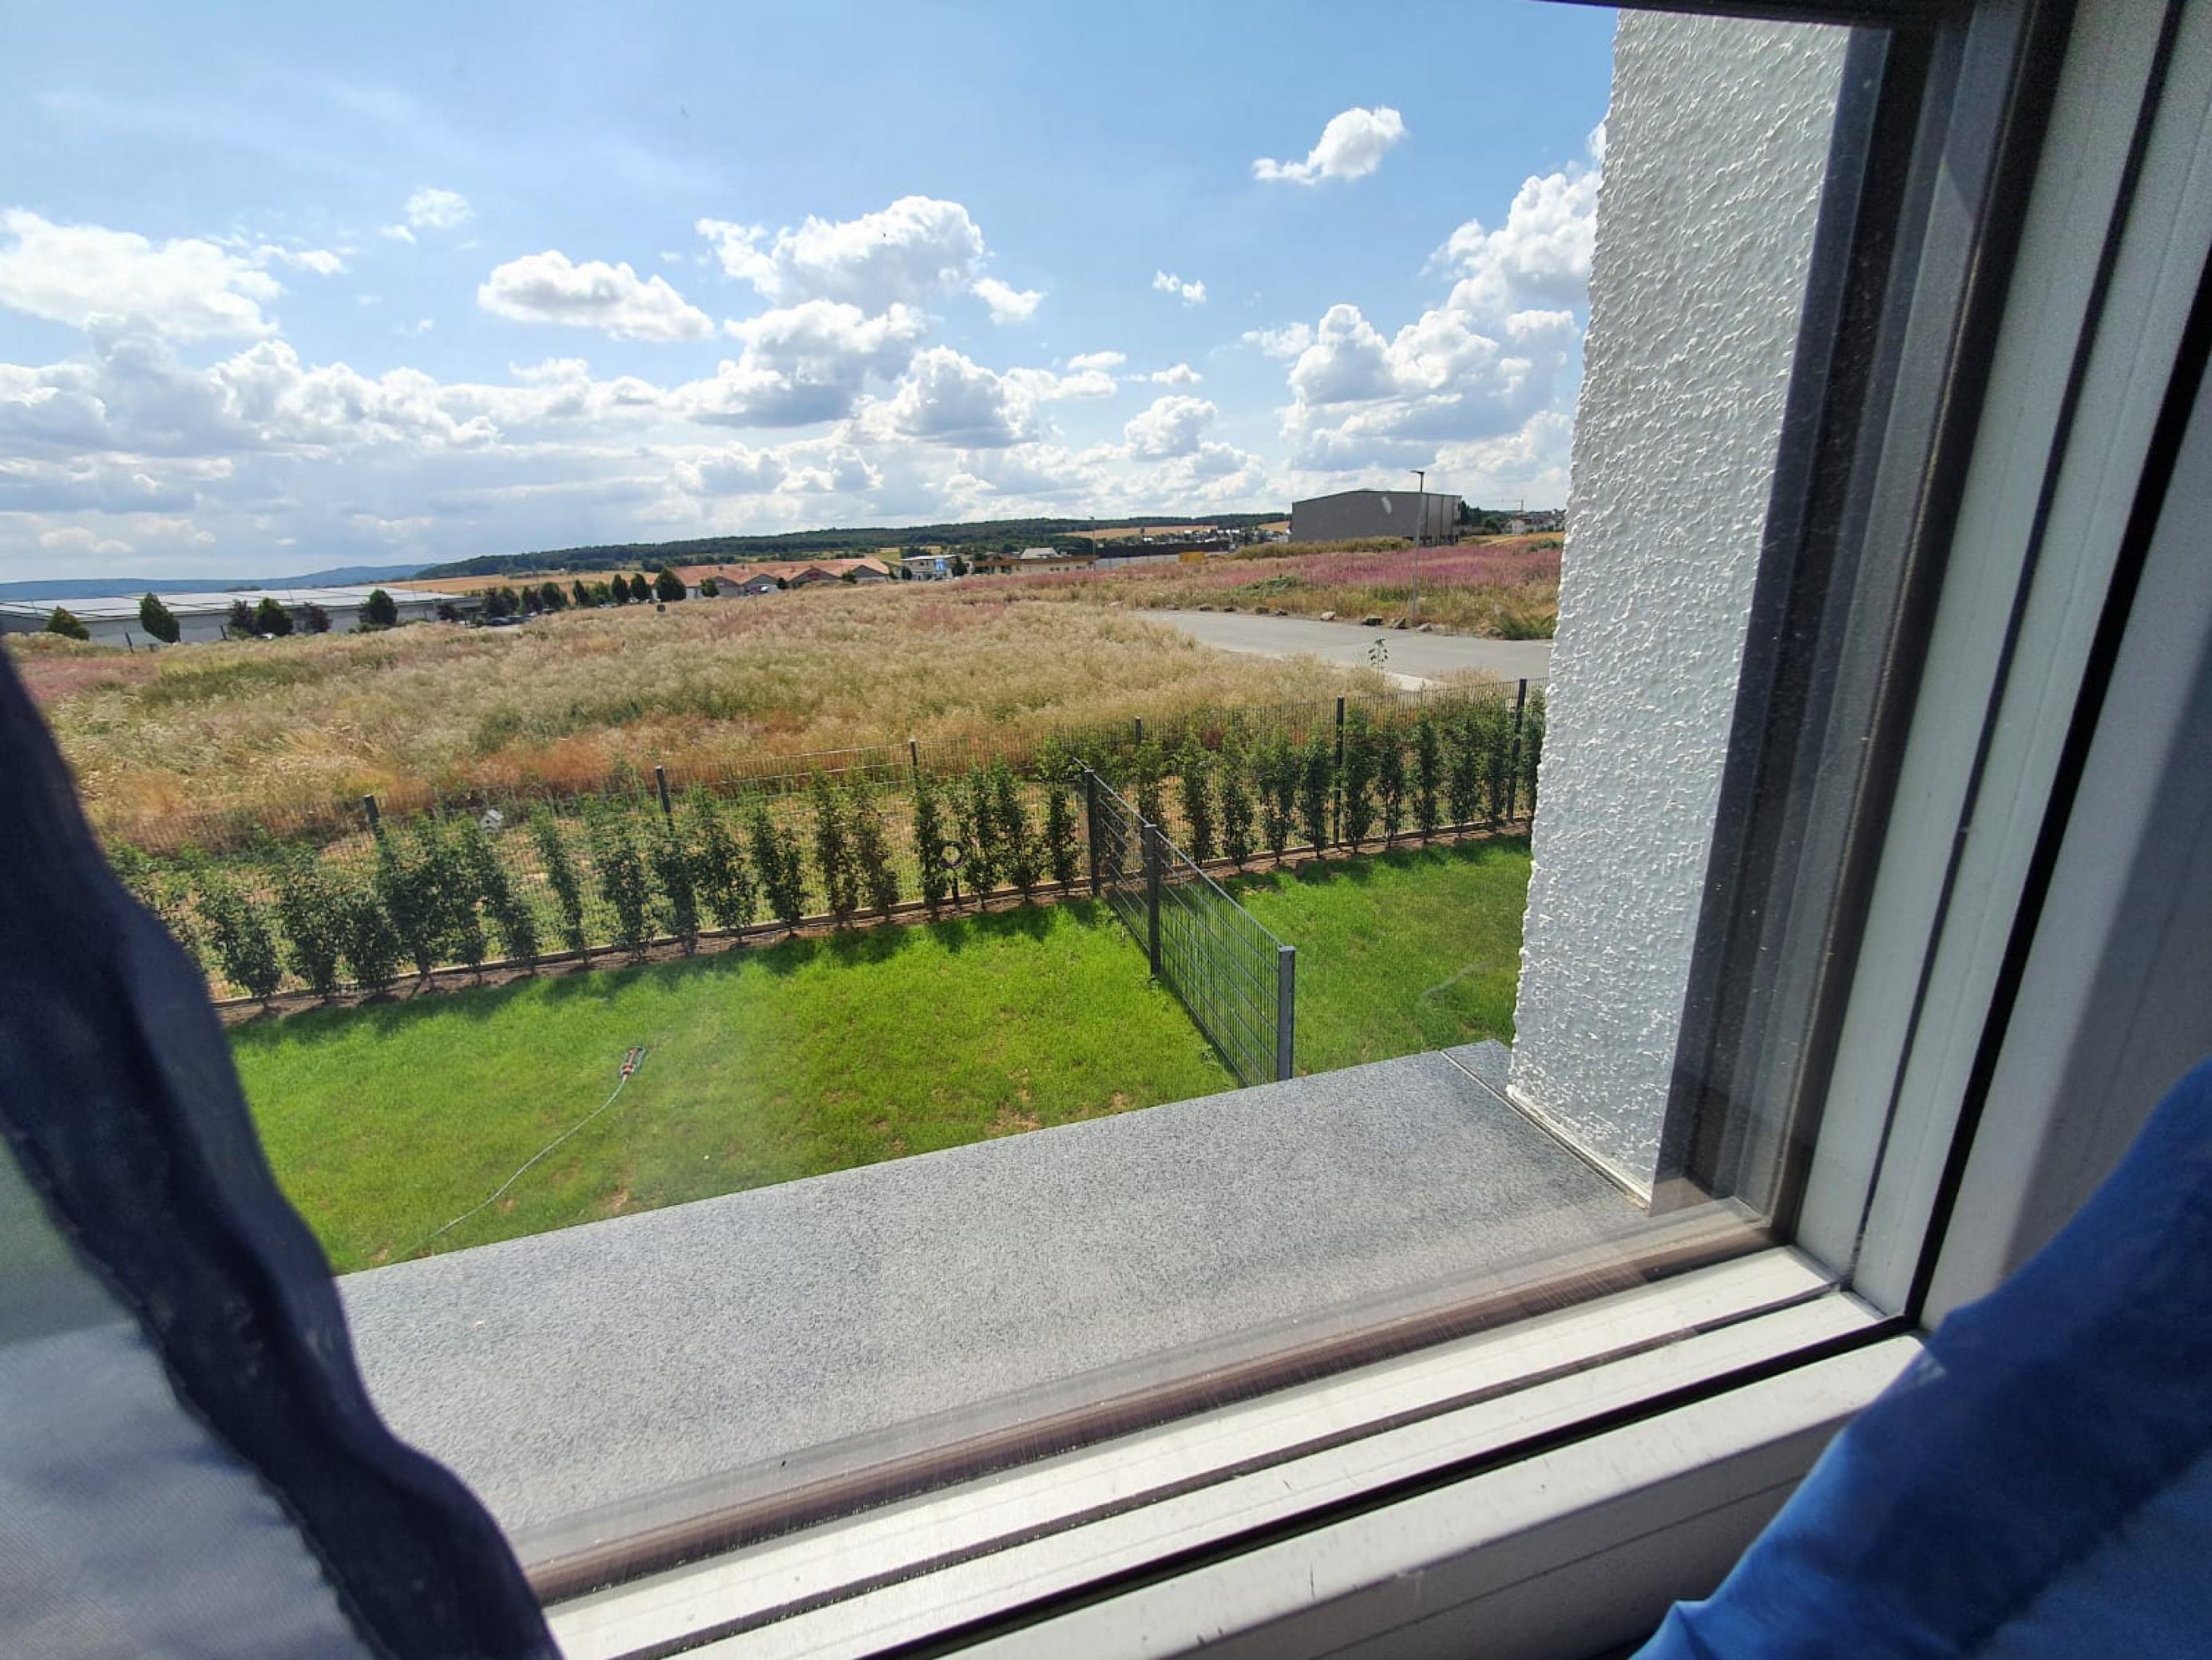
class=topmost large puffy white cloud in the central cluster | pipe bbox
[697,196,985,311]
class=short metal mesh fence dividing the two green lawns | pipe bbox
[1082,767,1298,1083]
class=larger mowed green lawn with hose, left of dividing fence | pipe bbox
[232,901,1232,1274]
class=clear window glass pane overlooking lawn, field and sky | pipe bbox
[0,6,1955,1609]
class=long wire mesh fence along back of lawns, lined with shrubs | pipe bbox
[109,683,1544,997]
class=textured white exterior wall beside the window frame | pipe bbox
[1511,11,1845,1191]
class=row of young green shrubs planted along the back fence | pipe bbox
[117,699,1542,1001]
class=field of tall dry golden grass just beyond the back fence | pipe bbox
[9,581,1382,835]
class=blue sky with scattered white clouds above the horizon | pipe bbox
[0,0,1612,577]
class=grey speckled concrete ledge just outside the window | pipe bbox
[341,1044,1639,1560]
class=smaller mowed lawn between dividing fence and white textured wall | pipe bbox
[1230,835,1528,1072]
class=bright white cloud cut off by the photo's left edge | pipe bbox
[0,208,283,340]
